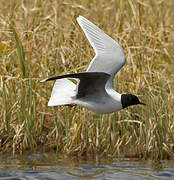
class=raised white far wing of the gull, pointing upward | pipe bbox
[77,16,126,87]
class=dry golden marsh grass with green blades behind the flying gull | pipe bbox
[0,0,174,160]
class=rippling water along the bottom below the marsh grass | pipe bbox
[0,153,174,180]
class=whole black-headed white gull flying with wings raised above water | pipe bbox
[41,16,145,114]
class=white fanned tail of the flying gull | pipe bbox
[48,79,76,106]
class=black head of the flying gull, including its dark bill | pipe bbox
[121,94,146,108]
